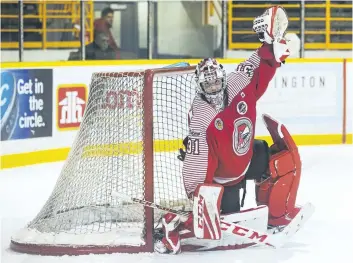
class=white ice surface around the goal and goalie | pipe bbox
[0,145,353,263]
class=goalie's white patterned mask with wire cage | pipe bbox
[195,58,227,110]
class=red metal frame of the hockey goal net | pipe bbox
[10,66,196,256]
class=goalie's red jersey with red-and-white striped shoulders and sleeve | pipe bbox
[183,46,279,198]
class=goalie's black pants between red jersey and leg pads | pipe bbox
[221,140,270,214]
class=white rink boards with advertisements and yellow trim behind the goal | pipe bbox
[1,59,353,168]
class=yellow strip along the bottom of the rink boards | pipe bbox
[0,134,353,169]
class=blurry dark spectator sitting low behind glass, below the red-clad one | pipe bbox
[69,32,116,60]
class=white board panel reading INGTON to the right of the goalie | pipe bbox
[226,62,343,135]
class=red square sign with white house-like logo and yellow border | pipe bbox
[56,84,88,130]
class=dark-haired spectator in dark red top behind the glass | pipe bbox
[94,7,119,58]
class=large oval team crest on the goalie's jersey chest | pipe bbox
[233,118,253,156]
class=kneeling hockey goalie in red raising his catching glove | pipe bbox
[155,6,311,254]
